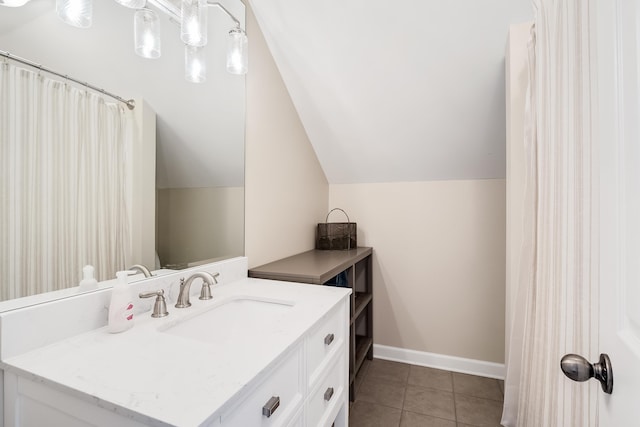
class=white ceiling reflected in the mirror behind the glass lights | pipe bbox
[0,0,245,188]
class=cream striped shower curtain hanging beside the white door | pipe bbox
[502,0,598,427]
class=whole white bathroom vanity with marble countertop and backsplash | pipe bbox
[0,258,350,427]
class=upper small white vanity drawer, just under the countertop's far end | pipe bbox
[306,301,348,388]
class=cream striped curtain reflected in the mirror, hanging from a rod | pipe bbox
[0,61,132,300]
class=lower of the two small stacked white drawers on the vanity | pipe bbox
[307,357,347,426]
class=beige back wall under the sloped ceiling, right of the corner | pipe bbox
[329,180,505,363]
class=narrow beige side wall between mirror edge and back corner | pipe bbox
[245,5,329,267]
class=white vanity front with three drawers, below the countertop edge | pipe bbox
[221,298,349,427]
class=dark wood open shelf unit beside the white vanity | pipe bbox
[249,247,373,401]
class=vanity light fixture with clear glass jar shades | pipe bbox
[47,0,248,83]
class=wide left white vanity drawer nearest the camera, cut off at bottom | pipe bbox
[221,347,303,427]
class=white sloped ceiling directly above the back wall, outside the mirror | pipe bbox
[249,0,533,183]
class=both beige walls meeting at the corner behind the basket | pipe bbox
[245,2,505,363]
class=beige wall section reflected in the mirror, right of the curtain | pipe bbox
[157,187,244,266]
